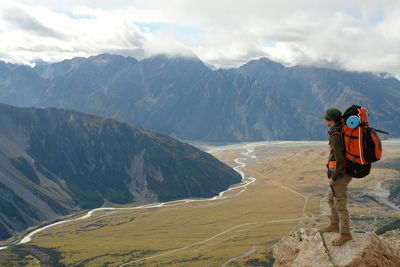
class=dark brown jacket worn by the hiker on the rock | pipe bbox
[328,125,344,181]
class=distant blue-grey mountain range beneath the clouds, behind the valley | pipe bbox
[0,54,400,141]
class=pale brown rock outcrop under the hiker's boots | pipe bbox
[273,228,400,267]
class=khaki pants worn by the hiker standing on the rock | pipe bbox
[326,174,352,234]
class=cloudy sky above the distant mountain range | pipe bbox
[0,0,400,77]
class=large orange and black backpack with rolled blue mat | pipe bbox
[342,105,388,178]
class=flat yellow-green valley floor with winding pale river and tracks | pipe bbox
[0,142,400,266]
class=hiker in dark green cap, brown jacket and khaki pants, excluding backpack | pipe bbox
[320,108,352,246]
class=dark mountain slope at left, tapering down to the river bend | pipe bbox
[0,104,241,239]
